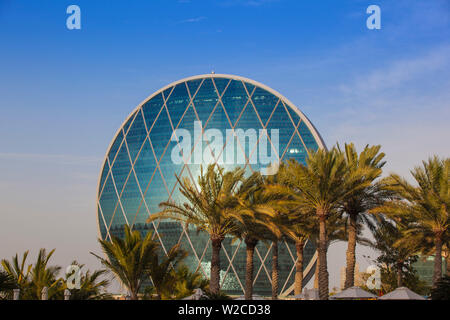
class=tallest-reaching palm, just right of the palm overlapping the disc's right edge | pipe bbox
[342,143,386,289]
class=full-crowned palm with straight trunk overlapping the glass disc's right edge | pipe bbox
[284,148,370,300]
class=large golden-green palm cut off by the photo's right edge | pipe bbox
[372,156,450,287]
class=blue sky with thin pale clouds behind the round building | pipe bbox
[0,0,450,286]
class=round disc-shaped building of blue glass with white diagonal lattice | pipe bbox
[97,74,324,295]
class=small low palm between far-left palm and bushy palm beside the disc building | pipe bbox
[66,261,112,300]
